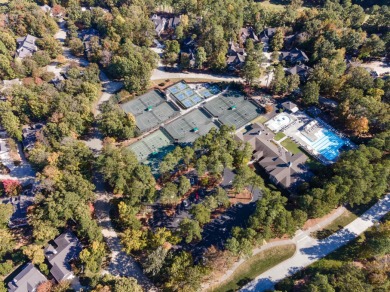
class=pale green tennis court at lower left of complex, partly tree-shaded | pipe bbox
[128,130,174,164]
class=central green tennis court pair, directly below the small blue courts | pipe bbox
[164,109,218,144]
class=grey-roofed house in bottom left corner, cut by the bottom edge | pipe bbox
[8,263,47,292]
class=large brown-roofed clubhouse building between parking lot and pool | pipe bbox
[236,123,311,190]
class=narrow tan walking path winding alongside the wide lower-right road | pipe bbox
[202,207,346,290]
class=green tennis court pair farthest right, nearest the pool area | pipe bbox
[205,92,261,129]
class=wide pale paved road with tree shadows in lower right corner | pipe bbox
[241,194,390,292]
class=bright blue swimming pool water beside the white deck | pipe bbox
[310,129,350,161]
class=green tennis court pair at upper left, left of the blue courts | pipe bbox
[121,90,180,133]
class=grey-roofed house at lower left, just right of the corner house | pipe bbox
[45,232,82,282]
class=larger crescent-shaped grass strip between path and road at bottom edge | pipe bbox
[211,244,295,292]
